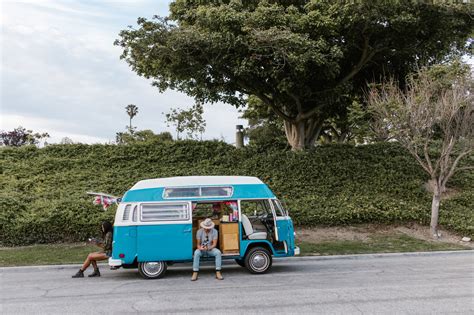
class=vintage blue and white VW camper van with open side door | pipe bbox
[109,176,299,279]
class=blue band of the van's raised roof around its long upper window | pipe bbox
[122,184,275,202]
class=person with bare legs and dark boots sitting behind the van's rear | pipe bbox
[72,221,113,278]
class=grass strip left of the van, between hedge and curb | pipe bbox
[0,244,100,267]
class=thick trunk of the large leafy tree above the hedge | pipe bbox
[284,118,323,151]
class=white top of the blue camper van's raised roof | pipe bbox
[130,176,263,190]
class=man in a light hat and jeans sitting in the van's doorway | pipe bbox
[191,218,224,281]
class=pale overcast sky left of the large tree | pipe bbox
[0,0,245,143]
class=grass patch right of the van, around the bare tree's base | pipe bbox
[298,234,469,255]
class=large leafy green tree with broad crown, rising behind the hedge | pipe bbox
[116,0,474,150]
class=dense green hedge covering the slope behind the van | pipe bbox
[0,141,474,246]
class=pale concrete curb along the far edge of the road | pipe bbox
[0,249,474,272]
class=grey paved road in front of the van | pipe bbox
[0,252,474,314]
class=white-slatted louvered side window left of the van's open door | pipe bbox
[141,203,189,221]
